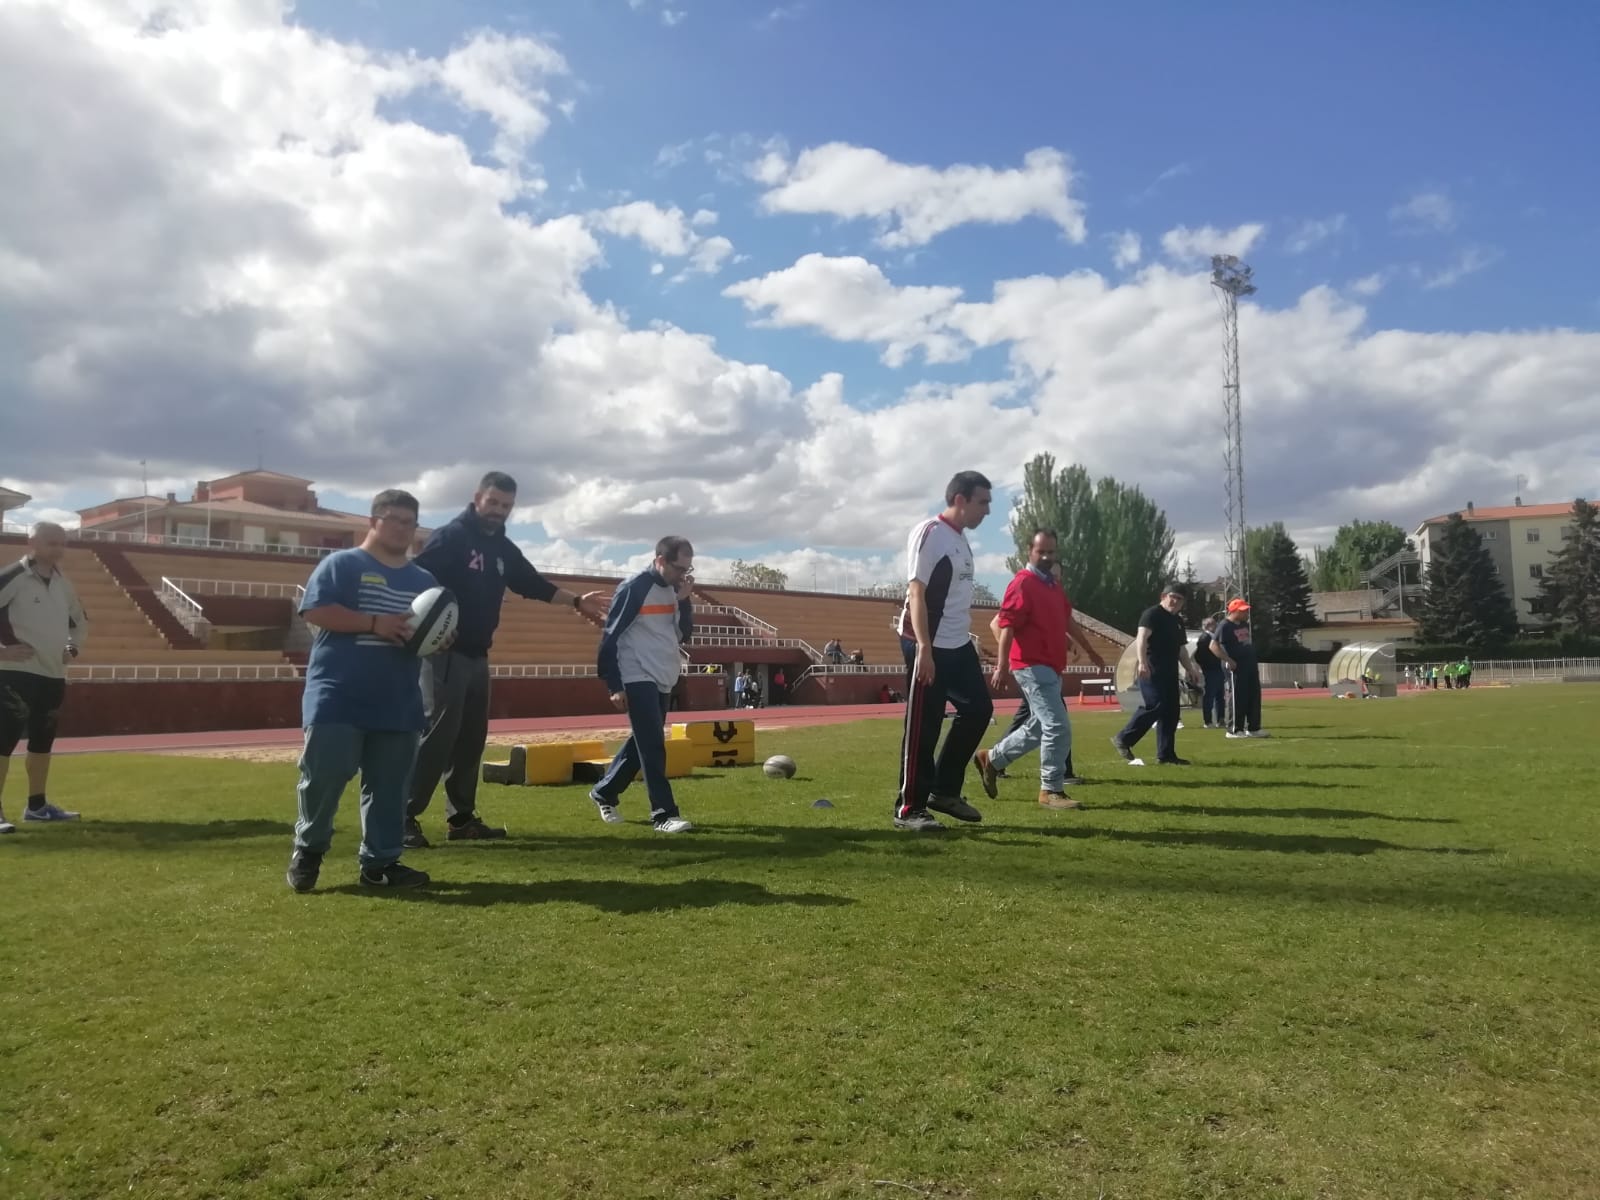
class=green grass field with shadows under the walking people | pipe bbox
[0,686,1600,1200]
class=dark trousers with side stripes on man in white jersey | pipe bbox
[894,638,995,816]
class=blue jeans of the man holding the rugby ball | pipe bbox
[294,725,421,869]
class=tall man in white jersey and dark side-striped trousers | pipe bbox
[894,470,995,829]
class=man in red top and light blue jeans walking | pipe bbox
[973,530,1086,808]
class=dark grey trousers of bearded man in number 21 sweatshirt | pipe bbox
[406,651,490,824]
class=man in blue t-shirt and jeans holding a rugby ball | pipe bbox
[288,490,435,891]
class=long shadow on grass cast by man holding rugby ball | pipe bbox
[325,878,856,914]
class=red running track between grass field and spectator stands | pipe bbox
[54,688,1328,754]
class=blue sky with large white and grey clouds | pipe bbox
[0,0,1600,598]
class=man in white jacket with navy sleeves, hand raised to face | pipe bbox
[589,538,694,834]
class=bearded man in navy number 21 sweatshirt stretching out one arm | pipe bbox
[405,470,605,850]
